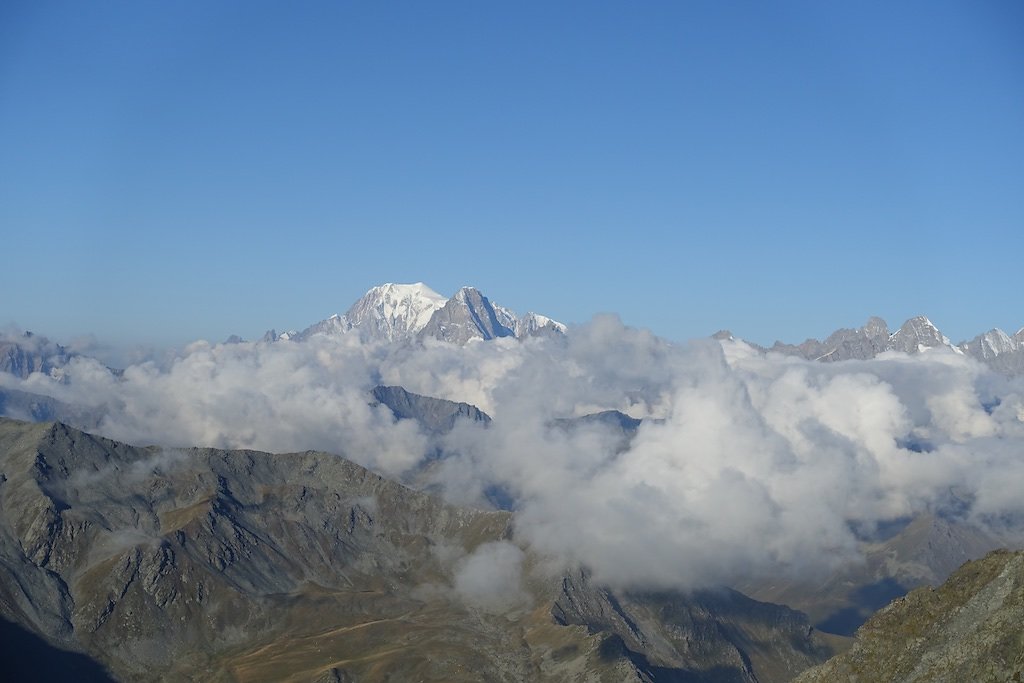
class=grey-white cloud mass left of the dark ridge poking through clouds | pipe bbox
[4,338,427,475]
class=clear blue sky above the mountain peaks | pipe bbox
[0,0,1024,344]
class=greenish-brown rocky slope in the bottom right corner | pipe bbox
[797,551,1024,683]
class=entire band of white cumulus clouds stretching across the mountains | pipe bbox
[5,316,1024,600]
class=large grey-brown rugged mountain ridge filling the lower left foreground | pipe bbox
[0,420,828,681]
